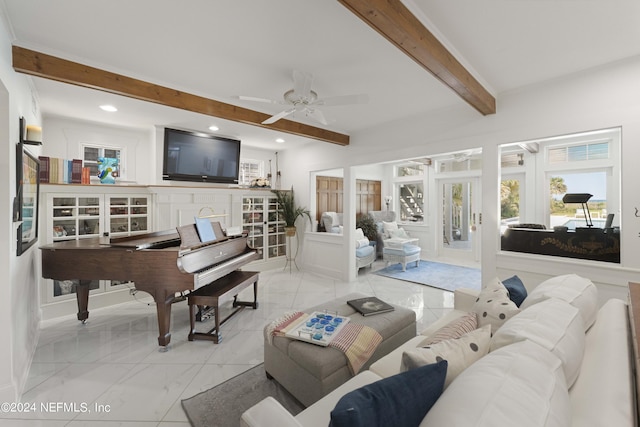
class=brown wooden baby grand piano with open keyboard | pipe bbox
[40,222,258,348]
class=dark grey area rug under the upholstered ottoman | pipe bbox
[182,364,304,427]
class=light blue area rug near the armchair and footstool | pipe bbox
[374,260,482,291]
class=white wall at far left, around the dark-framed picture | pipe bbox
[0,8,41,402]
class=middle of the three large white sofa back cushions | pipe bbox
[491,298,584,387]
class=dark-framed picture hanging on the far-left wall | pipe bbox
[16,143,40,256]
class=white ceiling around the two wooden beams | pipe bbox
[0,0,640,150]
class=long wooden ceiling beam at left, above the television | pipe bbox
[13,46,349,145]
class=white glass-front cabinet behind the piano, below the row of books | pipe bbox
[41,186,152,304]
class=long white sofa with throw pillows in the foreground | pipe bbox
[241,275,638,427]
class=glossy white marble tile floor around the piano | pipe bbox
[5,261,453,427]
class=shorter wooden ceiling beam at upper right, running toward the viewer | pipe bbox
[338,0,496,115]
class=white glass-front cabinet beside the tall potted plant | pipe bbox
[242,196,285,260]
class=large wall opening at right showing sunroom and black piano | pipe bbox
[500,128,621,263]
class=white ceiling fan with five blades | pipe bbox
[238,70,369,125]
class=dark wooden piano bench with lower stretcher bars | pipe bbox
[187,270,258,344]
